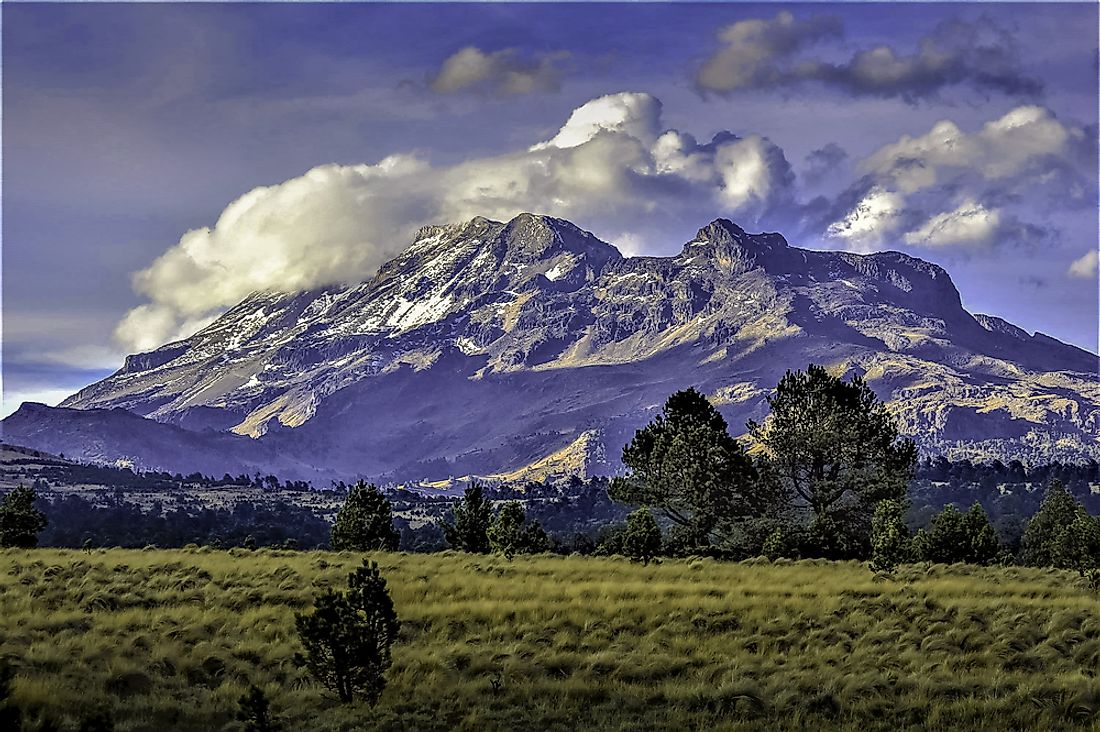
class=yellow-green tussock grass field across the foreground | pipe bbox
[0,549,1100,732]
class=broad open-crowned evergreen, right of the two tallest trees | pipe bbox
[748,365,916,556]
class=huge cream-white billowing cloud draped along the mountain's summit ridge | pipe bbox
[116,94,794,349]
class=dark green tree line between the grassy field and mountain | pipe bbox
[6,365,1096,562]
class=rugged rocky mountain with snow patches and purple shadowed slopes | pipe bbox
[2,214,1100,480]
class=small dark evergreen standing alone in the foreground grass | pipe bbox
[295,561,400,706]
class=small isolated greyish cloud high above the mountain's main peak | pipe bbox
[428,46,569,95]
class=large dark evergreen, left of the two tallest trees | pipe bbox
[608,389,768,539]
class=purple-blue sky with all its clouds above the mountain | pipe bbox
[2,3,1098,413]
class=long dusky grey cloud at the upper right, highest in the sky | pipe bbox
[695,11,1042,101]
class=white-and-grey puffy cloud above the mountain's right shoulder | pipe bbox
[826,106,1096,251]
